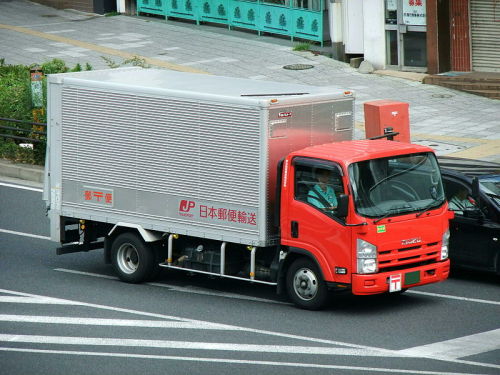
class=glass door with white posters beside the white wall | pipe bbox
[385,0,427,72]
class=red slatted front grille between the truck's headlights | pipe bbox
[378,242,440,272]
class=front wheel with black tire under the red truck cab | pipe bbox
[286,258,328,310]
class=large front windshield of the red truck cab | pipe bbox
[349,153,445,218]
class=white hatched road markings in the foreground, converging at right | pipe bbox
[0,289,500,374]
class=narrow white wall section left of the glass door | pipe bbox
[362,0,385,69]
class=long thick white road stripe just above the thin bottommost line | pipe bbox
[0,334,386,357]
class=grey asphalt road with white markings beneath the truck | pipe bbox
[0,181,500,375]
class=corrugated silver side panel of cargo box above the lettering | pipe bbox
[62,87,260,206]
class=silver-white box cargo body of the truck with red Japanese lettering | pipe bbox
[45,68,354,246]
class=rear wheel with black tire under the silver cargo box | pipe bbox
[111,233,157,283]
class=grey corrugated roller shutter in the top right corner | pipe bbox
[470,0,500,72]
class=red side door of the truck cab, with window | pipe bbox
[281,157,351,283]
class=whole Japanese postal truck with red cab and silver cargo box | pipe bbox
[44,68,450,309]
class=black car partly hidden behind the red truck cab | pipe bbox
[439,157,500,275]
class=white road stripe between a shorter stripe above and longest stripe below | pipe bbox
[0,316,235,331]
